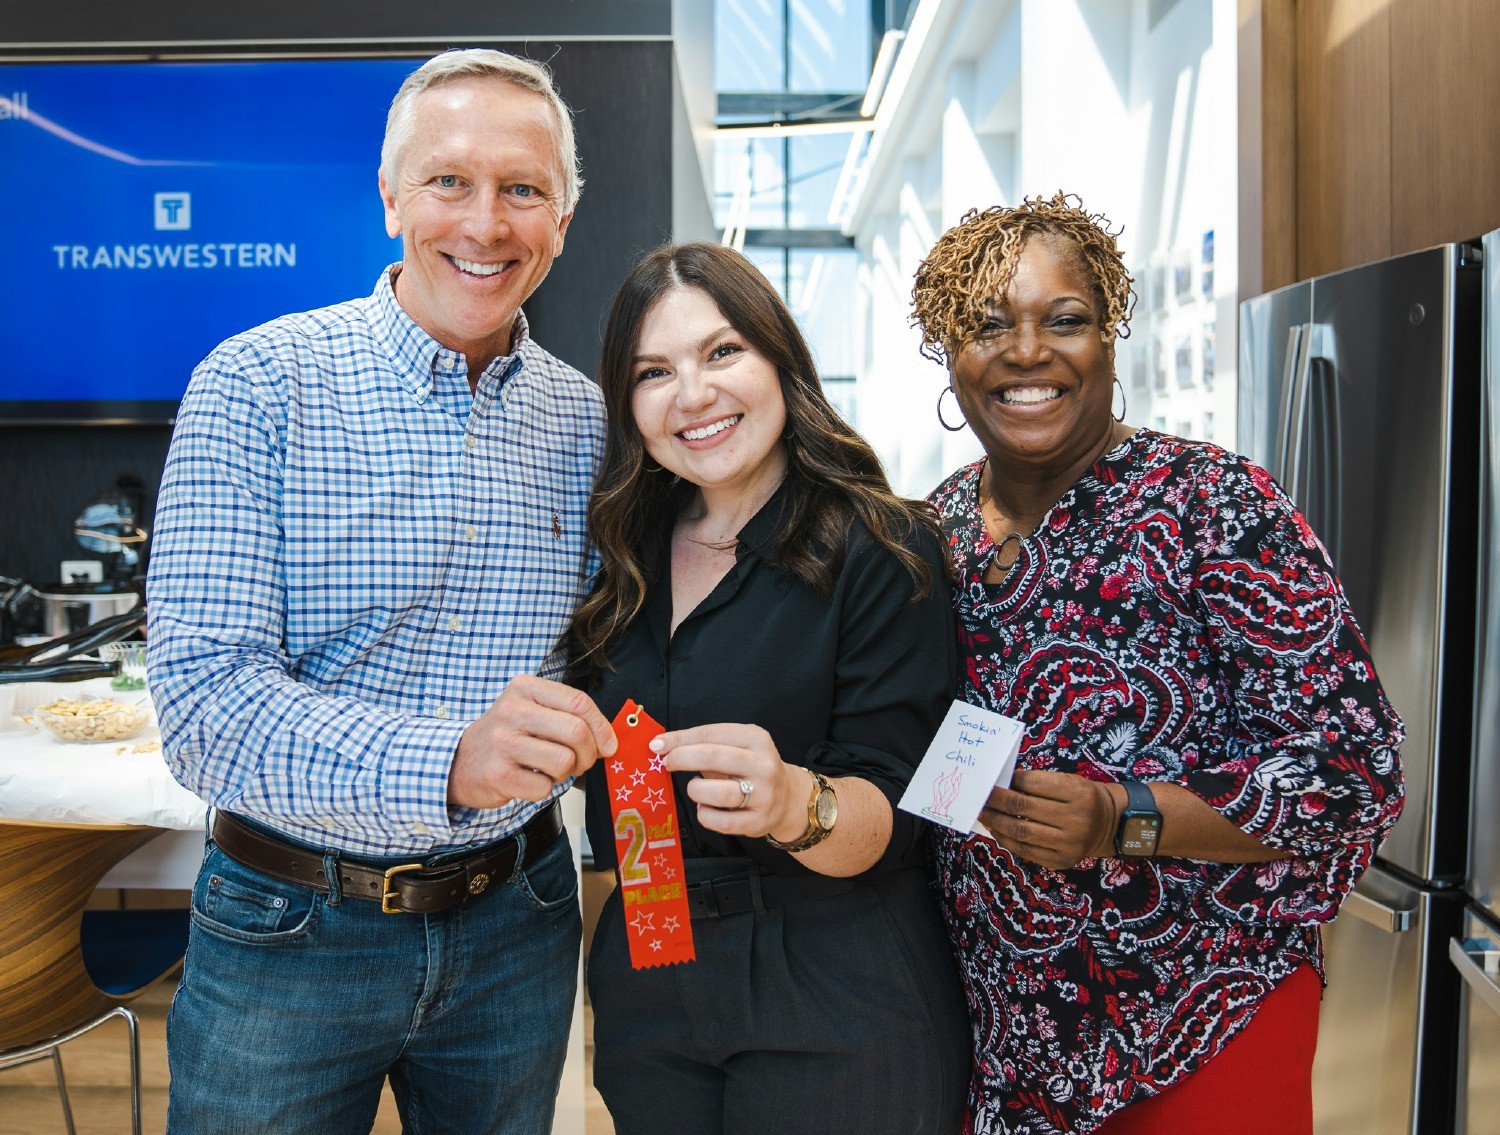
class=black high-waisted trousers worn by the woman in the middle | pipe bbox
[588,859,971,1135]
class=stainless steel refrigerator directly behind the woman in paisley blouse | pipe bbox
[1239,241,1500,1135]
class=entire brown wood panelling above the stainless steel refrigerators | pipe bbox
[1239,0,1500,289]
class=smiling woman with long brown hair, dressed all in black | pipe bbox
[572,244,968,1135]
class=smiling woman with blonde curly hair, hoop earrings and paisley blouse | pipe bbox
[914,193,1403,1135]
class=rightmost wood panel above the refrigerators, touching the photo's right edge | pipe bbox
[1391,0,1500,252]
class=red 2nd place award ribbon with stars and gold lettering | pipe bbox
[605,700,698,970]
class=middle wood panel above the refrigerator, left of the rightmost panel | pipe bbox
[1296,0,1392,279]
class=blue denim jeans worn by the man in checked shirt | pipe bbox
[167,834,581,1135]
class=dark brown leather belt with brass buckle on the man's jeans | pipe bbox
[213,802,563,915]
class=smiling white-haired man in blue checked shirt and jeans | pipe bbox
[147,51,615,1135]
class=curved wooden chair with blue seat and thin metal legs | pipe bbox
[0,820,188,1135]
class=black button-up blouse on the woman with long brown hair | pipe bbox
[585,489,959,876]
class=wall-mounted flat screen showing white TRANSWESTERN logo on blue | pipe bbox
[0,57,416,423]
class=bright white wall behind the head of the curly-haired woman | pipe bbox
[843,0,1236,495]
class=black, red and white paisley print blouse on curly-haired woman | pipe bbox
[930,430,1403,1135]
